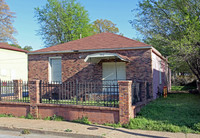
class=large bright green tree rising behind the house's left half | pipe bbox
[35,0,92,47]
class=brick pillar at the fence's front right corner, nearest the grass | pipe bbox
[118,81,133,124]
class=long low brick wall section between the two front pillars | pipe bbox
[38,104,119,124]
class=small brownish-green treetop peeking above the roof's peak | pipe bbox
[93,19,119,33]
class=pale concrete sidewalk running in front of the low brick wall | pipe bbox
[0,117,200,138]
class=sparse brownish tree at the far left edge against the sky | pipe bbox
[0,0,16,43]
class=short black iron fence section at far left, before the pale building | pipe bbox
[0,80,30,103]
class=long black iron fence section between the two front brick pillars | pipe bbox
[40,80,119,107]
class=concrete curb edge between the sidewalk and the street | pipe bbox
[0,126,102,138]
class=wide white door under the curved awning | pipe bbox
[102,62,126,92]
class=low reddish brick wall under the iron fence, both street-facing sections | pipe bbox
[0,102,119,124]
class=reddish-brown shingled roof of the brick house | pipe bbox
[31,33,150,54]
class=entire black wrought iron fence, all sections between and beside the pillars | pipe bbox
[0,80,151,107]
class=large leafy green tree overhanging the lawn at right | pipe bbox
[130,0,200,81]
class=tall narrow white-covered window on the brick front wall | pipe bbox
[49,57,62,82]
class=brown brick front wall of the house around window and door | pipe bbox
[28,49,152,90]
